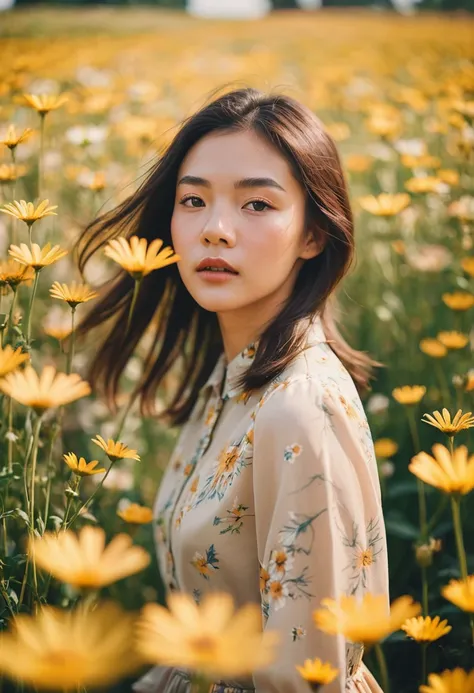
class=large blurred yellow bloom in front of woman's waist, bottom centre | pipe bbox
[137,592,279,678]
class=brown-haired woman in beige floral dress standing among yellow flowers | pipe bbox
[75,88,388,693]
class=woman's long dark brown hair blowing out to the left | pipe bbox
[74,88,379,424]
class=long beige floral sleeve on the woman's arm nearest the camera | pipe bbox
[253,374,388,693]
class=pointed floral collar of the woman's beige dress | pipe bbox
[200,315,327,399]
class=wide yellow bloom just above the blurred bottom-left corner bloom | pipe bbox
[29,525,150,588]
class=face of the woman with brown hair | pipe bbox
[171,131,318,318]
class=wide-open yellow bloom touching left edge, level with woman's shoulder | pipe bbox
[0,365,91,413]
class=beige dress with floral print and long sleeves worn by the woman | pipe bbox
[133,317,389,693]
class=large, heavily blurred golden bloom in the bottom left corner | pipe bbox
[0,602,139,691]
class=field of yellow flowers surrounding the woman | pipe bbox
[0,7,474,693]
